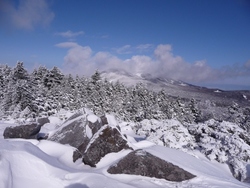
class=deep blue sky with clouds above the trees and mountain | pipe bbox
[0,0,250,89]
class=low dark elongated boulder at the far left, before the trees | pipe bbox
[3,123,41,139]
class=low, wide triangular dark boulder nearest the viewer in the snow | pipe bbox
[108,150,195,182]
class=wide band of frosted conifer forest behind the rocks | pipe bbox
[0,62,250,128]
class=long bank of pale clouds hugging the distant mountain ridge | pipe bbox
[56,42,250,83]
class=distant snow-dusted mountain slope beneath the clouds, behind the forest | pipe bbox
[101,70,250,106]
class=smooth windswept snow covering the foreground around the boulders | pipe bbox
[0,113,249,188]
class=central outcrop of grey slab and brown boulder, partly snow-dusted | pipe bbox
[49,112,117,163]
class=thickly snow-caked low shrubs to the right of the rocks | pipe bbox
[133,119,250,181]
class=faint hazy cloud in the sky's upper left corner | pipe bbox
[0,0,54,30]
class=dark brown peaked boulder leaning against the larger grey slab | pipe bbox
[82,125,133,167]
